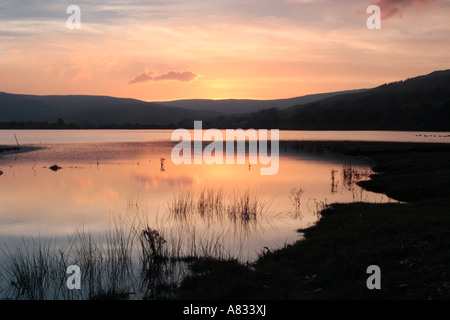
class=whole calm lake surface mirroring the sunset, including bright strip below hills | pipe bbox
[0,130,450,298]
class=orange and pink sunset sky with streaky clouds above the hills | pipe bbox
[0,0,450,101]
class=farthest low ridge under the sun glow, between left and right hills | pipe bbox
[157,89,367,114]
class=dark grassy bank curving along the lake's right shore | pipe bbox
[178,142,450,299]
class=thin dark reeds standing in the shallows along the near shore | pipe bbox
[3,188,282,300]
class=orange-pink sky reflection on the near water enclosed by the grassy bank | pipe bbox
[0,141,389,259]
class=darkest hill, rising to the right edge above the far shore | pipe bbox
[210,70,450,131]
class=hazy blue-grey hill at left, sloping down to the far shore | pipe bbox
[0,92,220,127]
